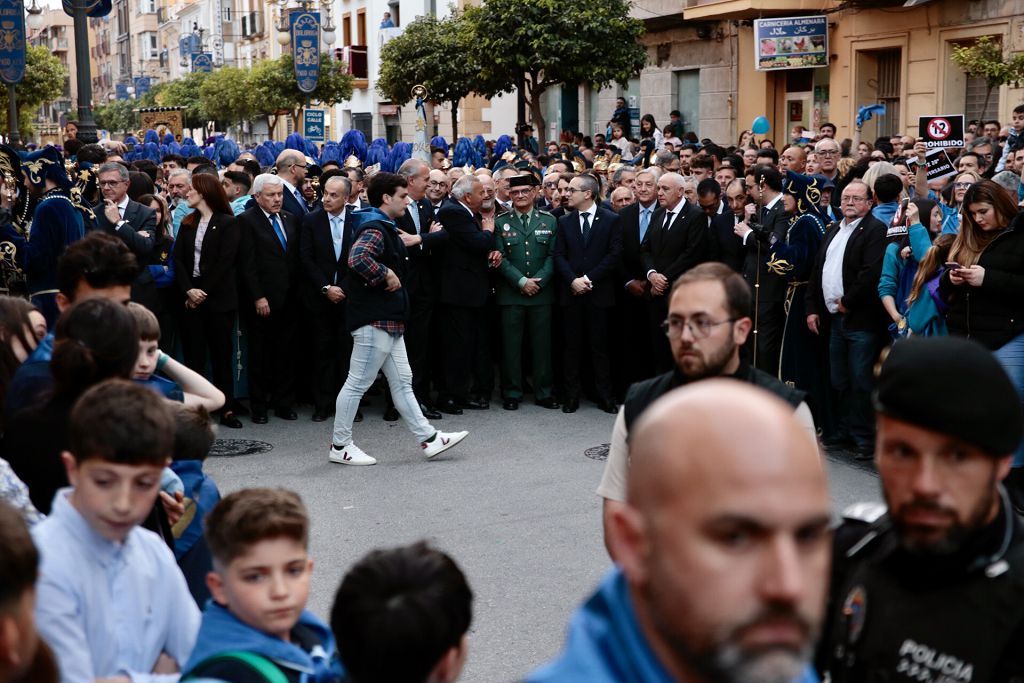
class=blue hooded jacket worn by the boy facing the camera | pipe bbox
[183,600,344,683]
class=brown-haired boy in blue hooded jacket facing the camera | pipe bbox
[184,488,342,683]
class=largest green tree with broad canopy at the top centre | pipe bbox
[466,0,647,145]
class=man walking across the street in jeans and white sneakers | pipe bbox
[328,173,469,465]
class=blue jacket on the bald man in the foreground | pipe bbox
[532,567,817,683]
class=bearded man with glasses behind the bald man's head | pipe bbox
[597,262,815,548]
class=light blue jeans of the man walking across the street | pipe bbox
[334,325,436,445]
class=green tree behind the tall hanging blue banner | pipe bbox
[249,53,352,130]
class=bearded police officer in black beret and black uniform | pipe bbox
[817,337,1024,683]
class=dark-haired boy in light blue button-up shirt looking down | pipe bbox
[33,380,200,683]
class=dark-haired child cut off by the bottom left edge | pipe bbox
[0,501,45,683]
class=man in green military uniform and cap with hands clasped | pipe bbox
[495,174,559,411]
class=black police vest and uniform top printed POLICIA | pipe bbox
[817,499,1024,683]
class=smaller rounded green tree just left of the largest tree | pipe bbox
[377,11,487,138]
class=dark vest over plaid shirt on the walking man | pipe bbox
[345,220,409,332]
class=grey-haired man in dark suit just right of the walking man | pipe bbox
[388,159,447,420]
